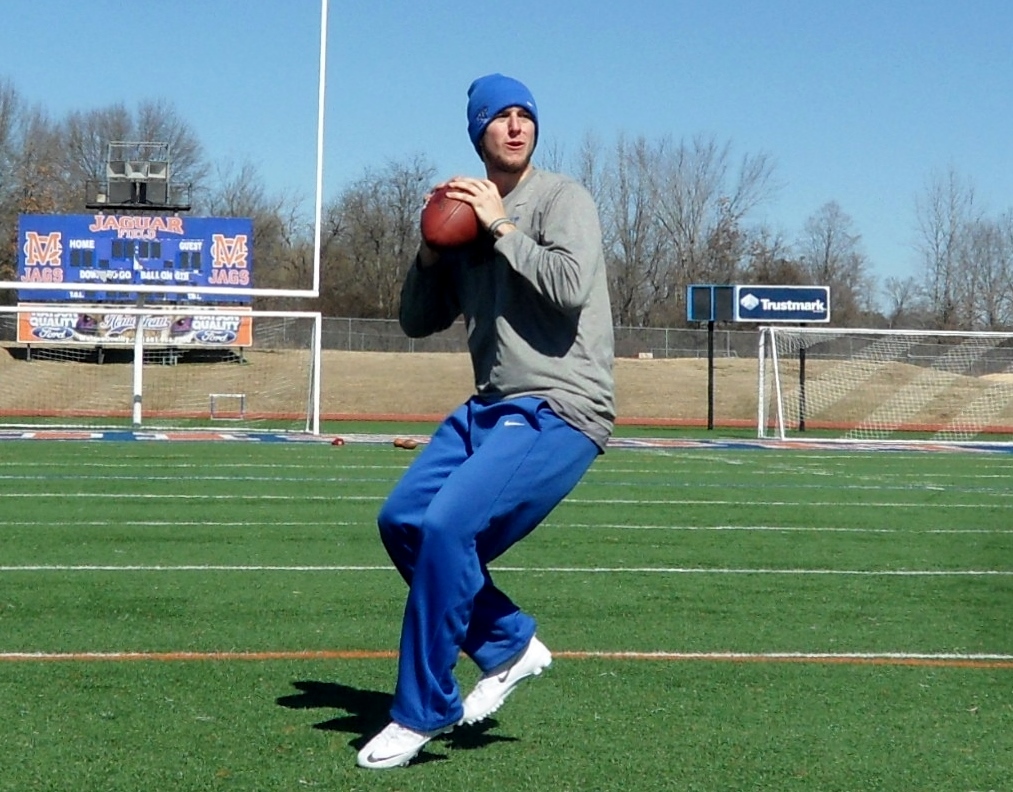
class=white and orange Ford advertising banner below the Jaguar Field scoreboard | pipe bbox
[17,304,253,347]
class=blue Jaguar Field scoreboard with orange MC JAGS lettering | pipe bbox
[17,214,253,305]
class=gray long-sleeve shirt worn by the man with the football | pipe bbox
[400,170,615,448]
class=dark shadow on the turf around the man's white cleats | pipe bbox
[278,680,517,764]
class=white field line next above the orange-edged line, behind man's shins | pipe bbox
[0,564,1013,577]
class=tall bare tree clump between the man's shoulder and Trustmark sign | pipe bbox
[577,136,776,325]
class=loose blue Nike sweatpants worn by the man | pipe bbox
[377,397,599,731]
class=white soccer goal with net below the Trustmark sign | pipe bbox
[757,325,1013,443]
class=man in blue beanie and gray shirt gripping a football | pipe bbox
[358,74,615,769]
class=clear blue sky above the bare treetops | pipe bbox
[0,0,1013,281]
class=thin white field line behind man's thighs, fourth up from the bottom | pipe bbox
[0,492,1013,510]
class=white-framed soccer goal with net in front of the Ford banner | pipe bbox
[0,304,321,434]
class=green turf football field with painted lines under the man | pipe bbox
[0,441,1013,792]
